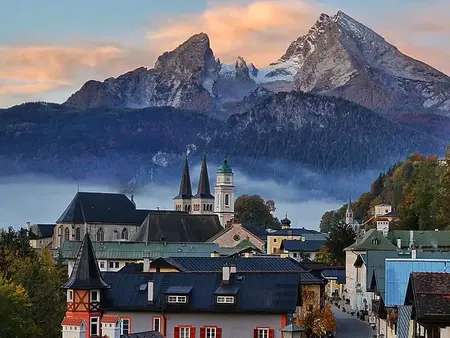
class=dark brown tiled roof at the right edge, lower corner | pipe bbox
[405,272,450,326]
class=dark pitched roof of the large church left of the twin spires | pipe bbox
[56,192,149,225]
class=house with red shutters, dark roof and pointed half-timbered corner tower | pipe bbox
[61,234,302,338]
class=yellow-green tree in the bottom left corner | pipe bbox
[0,273,37,338]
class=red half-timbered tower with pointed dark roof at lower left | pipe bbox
[61,233,109,338]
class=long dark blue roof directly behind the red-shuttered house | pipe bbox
[151,256,323,284]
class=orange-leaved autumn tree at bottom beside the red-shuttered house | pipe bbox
[296,304,336,338]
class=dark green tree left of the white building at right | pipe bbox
[325,223,356,265]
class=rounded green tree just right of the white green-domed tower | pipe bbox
[234,195,280,229]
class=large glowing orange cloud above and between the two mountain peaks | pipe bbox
[147,0,320,66]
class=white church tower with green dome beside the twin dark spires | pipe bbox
[214,156,234,227]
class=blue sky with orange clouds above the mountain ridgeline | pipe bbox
[0,0,450,108]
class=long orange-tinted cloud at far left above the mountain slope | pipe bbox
[0,45,151,106]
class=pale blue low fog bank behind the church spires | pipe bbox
[0,172,345,229]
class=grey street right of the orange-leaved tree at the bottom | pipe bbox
[333,306,375,338]
